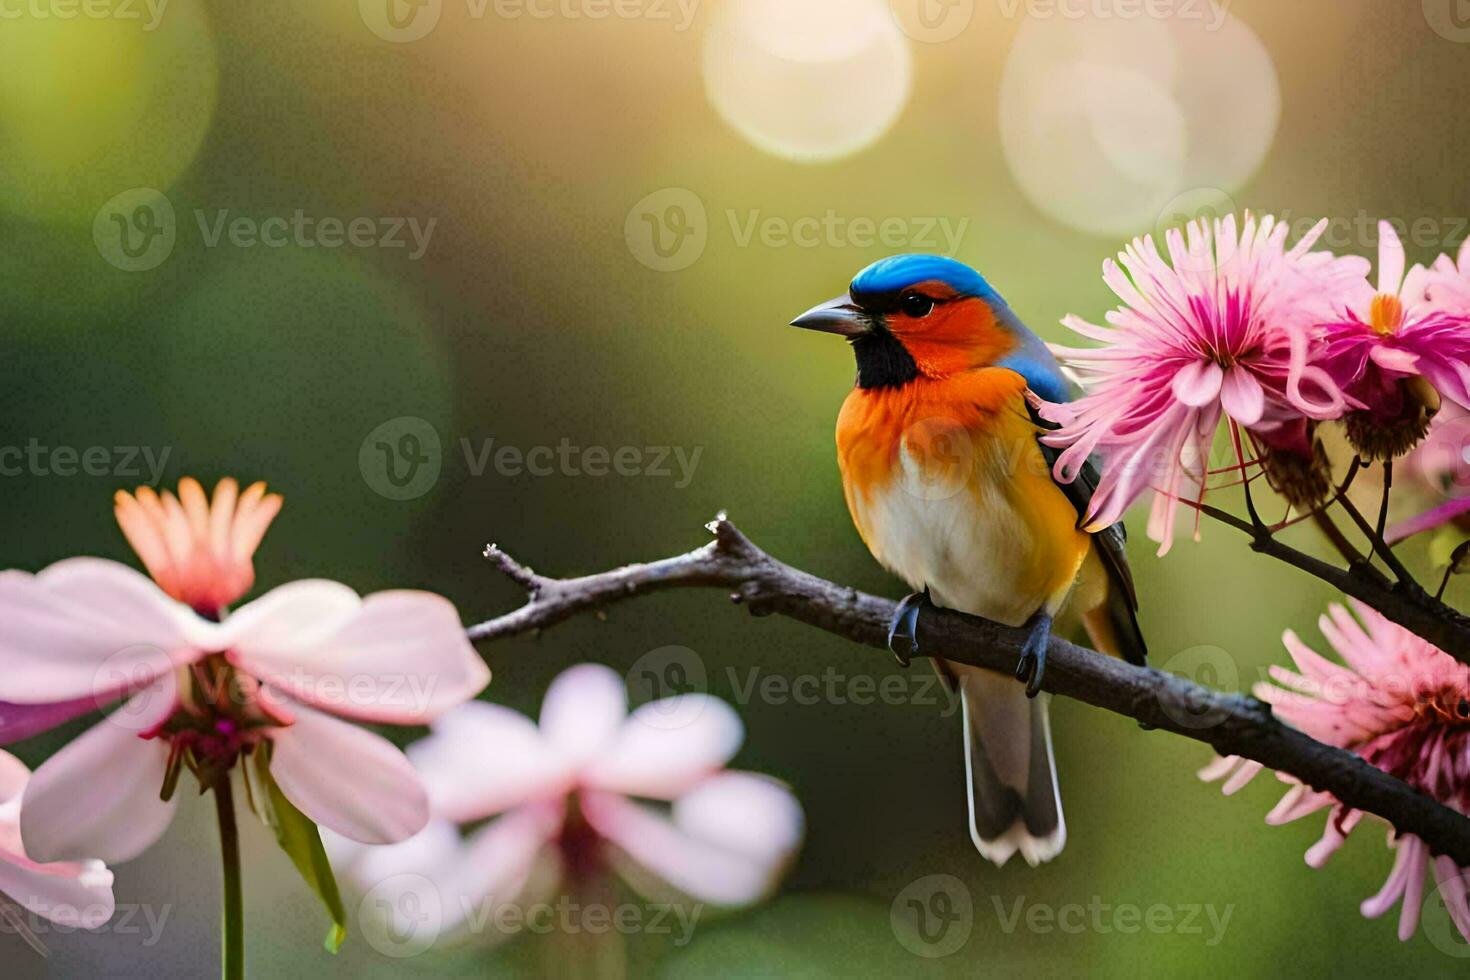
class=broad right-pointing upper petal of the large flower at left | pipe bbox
[229,582,490,724]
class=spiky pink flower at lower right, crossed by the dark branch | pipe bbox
[1200,602,1470,940]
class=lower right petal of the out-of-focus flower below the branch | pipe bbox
[582,773,801,905]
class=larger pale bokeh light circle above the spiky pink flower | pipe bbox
[1000,0,1280,237]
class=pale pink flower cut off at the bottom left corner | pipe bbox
[0,751,113,929]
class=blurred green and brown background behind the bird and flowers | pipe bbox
[0,0,1470,977]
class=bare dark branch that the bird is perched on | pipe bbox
[469,514,1470,865]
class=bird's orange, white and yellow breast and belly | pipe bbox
[836,367,1091,626]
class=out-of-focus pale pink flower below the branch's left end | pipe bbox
[328,664,803,937]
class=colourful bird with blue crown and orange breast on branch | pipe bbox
[792,256,1147,865]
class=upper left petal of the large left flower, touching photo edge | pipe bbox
[0,558,203,705]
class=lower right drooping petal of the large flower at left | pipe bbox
[270,693,429,843]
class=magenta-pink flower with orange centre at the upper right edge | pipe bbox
[1319,222,1470,458]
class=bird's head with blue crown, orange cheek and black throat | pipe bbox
[791,256,1069,401]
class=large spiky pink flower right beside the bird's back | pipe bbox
[1042,215,1367,554]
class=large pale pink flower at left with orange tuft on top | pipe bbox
[0,482,490,862]
